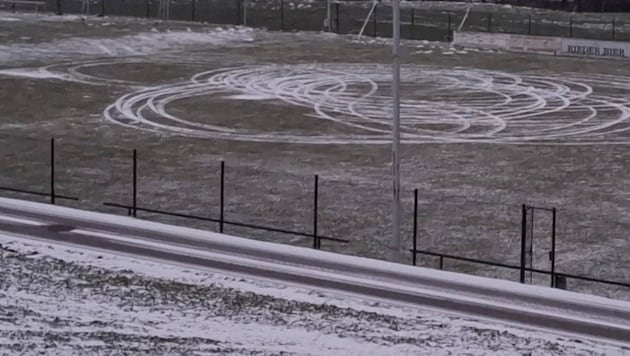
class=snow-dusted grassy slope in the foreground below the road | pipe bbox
[0,236,630,355]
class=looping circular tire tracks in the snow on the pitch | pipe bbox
[59,60,630,145]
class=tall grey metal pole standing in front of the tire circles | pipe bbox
[391,0,402,262]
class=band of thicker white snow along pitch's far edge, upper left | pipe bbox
[0,11,466,69]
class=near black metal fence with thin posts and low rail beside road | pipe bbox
[0,138,630,298]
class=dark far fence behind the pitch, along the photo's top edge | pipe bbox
[0,0,630,41]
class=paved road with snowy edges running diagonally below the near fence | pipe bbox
[0,198,630,345]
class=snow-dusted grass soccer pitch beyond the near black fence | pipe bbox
[0,14,630,295]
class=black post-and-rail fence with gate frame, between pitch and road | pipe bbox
[0,134,630,298]
